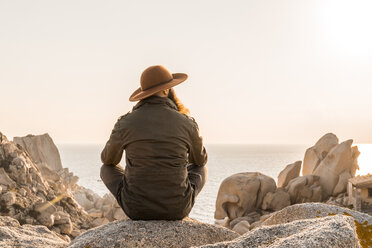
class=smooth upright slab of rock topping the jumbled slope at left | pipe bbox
[13,133,62,171]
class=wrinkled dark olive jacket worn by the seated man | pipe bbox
[101,96,207,219]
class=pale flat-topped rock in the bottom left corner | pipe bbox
[0,216,68,248]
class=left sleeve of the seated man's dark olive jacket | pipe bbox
[101,120,124,166]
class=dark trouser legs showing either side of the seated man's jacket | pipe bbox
[101,164,207,212]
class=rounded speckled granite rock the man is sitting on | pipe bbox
[70,218,239,248]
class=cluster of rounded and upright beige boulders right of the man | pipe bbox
[215,133,359,233]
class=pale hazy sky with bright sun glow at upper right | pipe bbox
[0,0,372,144]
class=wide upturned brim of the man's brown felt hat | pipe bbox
[129,73,187,102]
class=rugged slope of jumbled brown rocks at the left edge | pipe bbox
[0,133,93,240]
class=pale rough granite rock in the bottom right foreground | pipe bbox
[200,215,360,248]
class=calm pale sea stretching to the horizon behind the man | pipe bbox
[58,144,372,224]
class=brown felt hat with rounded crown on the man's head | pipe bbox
[129,65,187,102]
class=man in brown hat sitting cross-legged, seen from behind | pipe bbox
[101,65,207,220]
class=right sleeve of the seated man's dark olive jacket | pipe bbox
[189,122,208,166]
